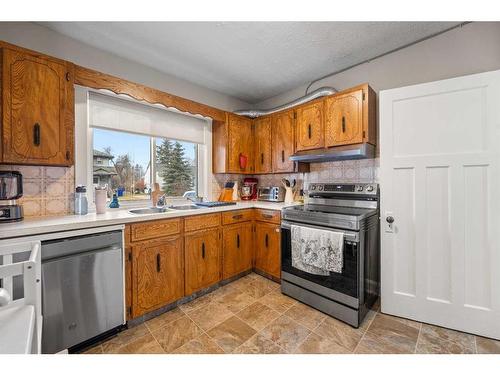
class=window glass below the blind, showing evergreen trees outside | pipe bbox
[93,129,198,202]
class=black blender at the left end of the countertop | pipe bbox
[0,171,23,223]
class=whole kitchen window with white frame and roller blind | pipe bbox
[75,87,212,207]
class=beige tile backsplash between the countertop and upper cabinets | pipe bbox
[0,159,379,217]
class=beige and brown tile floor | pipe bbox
[81,273,500,354]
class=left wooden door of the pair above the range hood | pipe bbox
[296,101,325,151]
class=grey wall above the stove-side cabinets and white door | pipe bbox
[255,22,500,109]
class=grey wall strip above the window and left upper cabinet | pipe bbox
[0,22,249,111]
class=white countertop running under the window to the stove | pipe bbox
[0,201,300,239]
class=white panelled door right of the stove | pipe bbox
[380,71,500,339]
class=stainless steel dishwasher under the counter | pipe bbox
[42,230,125,353]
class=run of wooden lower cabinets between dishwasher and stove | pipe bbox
[124,209,281,320]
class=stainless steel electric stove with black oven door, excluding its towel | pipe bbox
[281,183,380,327]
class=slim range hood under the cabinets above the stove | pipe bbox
[290,143,375,163]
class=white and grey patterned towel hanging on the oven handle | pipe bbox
[291,225,344,276]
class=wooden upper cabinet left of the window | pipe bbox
[1,48,74,166]
